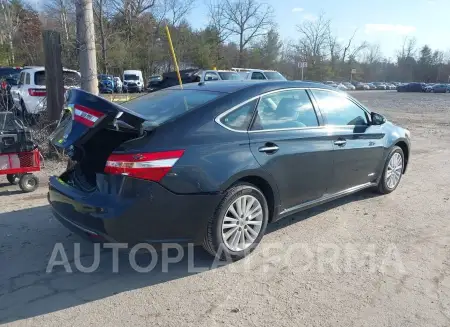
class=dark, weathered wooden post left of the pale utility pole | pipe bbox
[42,31,64,122]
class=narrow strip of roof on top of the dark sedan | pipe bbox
[165,80,336,93]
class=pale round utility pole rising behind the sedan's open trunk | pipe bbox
[75,0,98,95]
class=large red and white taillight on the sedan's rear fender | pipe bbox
[105,150,184,182]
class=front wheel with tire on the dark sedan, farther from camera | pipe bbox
[377,146,405,194]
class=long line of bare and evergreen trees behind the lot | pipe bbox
[0,0,450,82]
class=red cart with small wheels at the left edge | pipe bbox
[0,148,41,192]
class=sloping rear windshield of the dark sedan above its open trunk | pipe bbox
[122,90,222,126]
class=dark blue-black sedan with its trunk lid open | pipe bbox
[49,81,410,259]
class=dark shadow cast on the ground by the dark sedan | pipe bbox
[0,192,373,323]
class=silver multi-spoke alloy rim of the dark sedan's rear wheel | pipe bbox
[222,195,263,252]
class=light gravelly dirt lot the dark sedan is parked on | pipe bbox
[0,91,450,327]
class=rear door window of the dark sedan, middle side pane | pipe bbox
[252,90,319,130]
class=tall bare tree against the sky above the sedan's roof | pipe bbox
[223,0,274,66]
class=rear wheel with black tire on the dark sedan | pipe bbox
[203,183,269,261]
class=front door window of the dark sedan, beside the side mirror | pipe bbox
[312,90,368,126]
